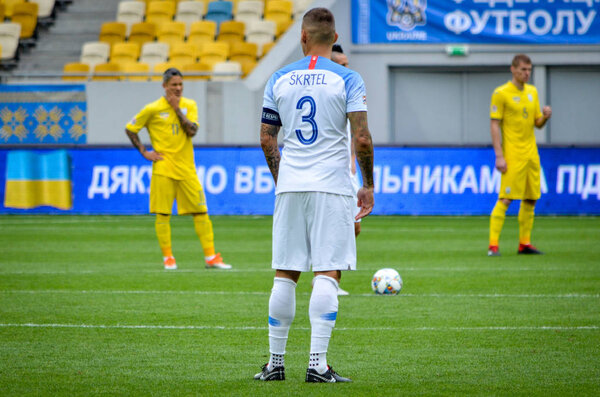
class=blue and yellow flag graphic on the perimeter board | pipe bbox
[4,150,73,210]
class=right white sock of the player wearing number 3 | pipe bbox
[308,275,339,374]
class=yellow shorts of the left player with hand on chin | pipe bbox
[150,175,208,215]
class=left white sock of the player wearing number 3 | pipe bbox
[267,277,296,370]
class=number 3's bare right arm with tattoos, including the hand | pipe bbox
[348,112,375,220]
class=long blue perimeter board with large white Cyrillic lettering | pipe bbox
[0,147,600,215]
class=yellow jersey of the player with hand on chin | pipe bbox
[126,96,198,180]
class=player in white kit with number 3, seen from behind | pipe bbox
[254,8,374,383]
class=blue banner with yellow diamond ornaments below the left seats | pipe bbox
[0,84,87,145]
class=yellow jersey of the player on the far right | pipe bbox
[490,81,542,160]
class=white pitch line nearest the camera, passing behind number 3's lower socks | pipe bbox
[0,323,600,332]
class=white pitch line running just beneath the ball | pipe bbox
[0,289,600,299]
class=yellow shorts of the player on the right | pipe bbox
[499,159,542,200]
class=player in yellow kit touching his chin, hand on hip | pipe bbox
[125,68,231,270]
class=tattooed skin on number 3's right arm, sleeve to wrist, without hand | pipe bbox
[348,112,374,188]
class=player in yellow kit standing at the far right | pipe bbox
[488,54,552,256]
